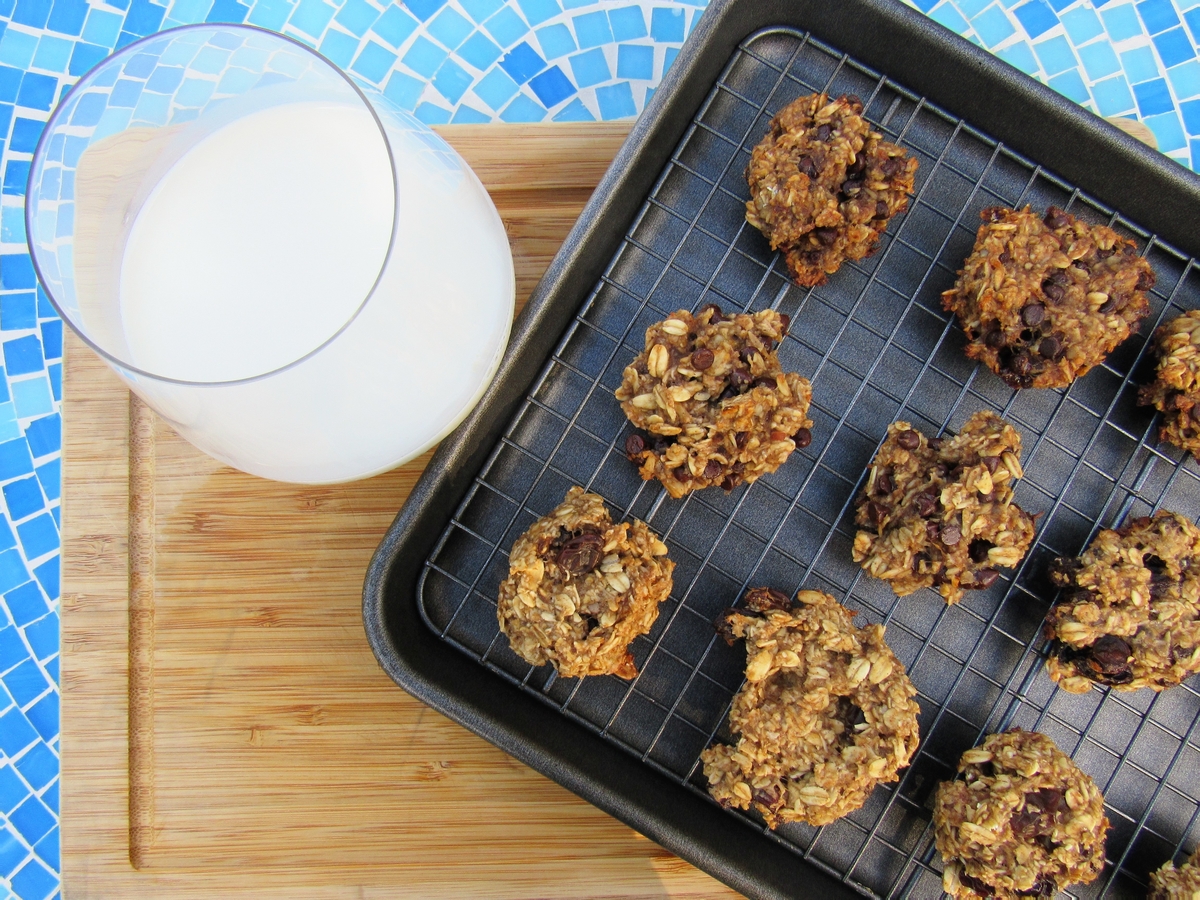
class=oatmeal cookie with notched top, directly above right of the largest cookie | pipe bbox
[852,410,1034,604]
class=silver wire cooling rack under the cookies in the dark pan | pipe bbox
[420,24,1200,898]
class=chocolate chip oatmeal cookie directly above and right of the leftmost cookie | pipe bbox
[617,304,812,497]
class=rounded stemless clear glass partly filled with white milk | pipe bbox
[25,25,515,484]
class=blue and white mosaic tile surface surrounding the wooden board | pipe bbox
[0,0,1200,900]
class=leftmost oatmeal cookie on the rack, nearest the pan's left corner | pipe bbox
[496,487,674,678]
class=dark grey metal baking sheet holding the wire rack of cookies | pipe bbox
[364,0,1200,896]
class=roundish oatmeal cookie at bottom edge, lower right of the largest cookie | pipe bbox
[934,730,1109,900]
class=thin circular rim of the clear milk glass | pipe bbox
[24,23,400,388]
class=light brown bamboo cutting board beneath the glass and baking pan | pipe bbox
[61,125,733,900]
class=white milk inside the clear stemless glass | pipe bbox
[83,101,514,482]
